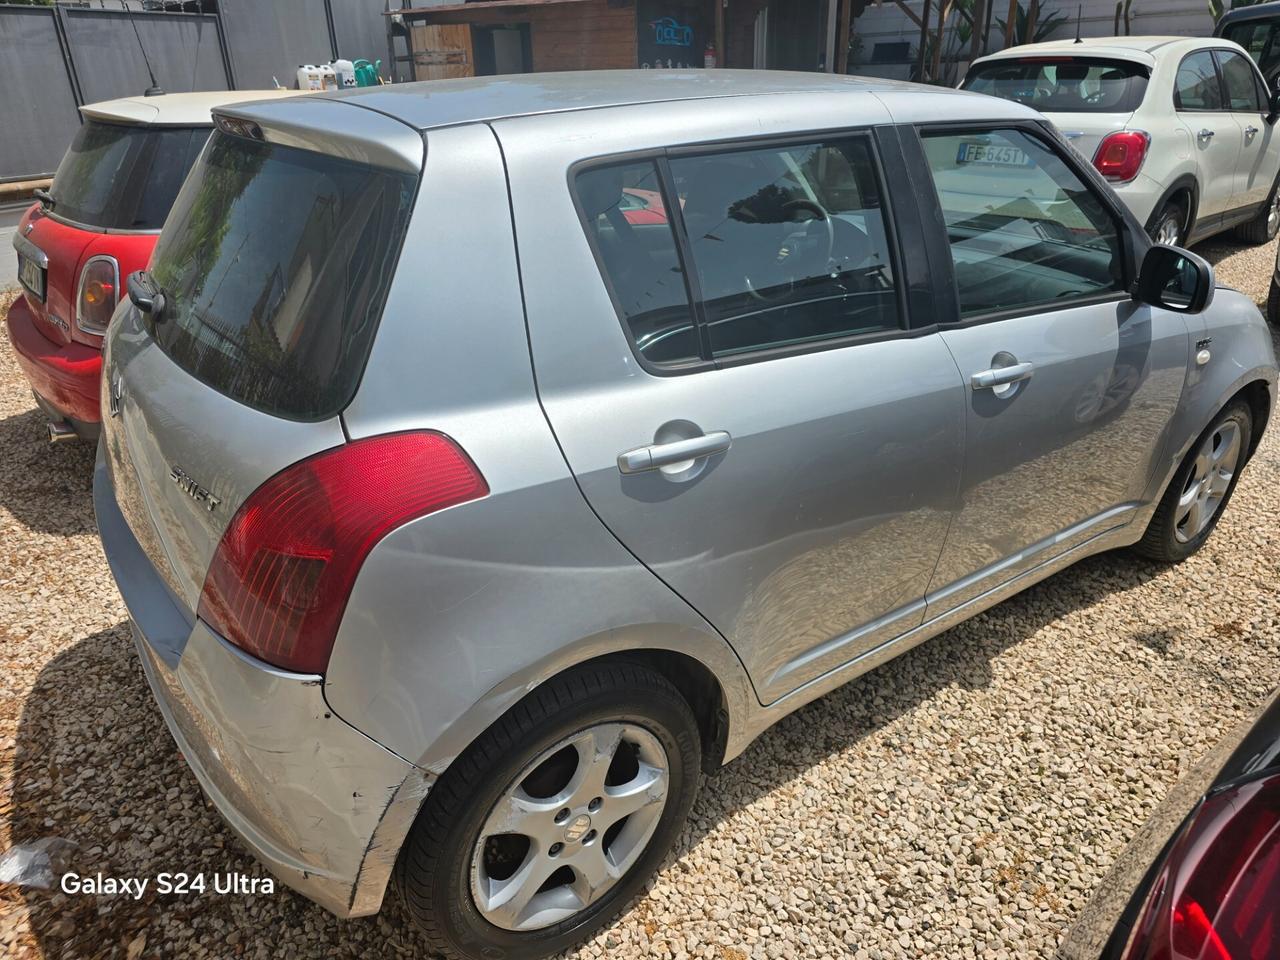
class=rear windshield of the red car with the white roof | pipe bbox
[50,120,209,230]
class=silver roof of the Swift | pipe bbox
[267,69,1034,131]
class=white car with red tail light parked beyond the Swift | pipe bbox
[961,37,1280,244]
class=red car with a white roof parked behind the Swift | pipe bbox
[6,90,297,440]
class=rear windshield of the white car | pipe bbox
[964,56,1147,114]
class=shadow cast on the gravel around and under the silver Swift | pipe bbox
[10,554,1160,960]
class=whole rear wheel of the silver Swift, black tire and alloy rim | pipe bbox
[397,663,701,960]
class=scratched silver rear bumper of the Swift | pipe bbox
[93,448,430,916]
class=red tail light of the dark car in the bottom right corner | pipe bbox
[1124,776,1280,960]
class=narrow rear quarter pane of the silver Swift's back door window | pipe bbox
[575,160,700,365]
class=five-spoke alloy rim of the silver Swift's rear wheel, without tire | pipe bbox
[471,723,669,931]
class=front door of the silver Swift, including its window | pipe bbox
[920,127,1188,617]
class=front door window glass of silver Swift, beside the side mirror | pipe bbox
[923,129,1124,317]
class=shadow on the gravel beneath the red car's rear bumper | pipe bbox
[0,408,97,536]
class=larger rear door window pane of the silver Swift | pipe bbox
[671,137,900,357]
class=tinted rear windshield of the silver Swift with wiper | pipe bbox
[151,132,417,420]
